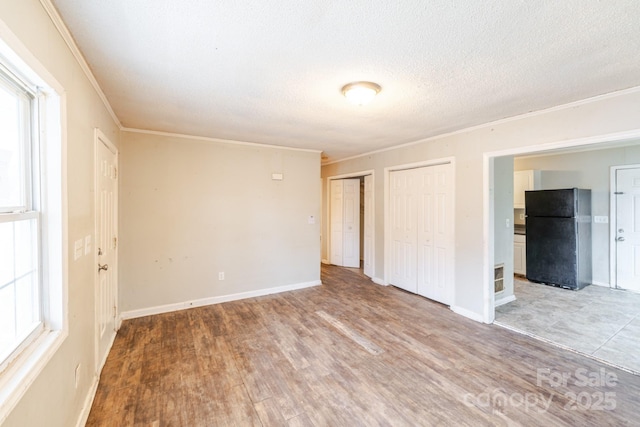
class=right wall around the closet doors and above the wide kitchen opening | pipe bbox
[322,88,640,321]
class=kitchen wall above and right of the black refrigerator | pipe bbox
[514,141,640,286]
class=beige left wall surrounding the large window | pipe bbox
[0,0,119,427]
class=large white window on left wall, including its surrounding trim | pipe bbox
[0,25,68,424]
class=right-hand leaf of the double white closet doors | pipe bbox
[416,164,453,305]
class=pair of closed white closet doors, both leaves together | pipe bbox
[389,164,453,305]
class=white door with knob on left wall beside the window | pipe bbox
[95,132,118,372]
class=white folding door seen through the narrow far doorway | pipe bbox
[330,179,360,268]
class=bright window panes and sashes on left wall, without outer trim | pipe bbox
[0,65,42,368]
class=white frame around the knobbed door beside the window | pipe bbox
[93,128,121,375]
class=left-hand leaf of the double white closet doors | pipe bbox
[389,169,418,293]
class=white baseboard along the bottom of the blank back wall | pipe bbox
[120,280,322,320]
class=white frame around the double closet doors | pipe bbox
[383,157,456,296]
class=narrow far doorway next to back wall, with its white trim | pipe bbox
[328,171,375,278]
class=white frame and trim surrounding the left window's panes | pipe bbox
[0,21,69,425]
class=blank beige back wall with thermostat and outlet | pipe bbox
[119,132,321,317]
